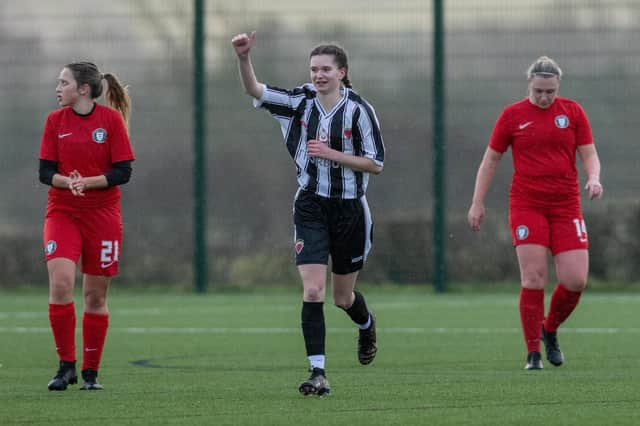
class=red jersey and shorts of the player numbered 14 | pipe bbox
[489,97,593,255]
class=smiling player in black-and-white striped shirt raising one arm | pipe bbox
[232,32,384,395]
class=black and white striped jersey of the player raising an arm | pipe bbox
[254,83,384,199]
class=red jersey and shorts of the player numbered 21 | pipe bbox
[40,103,133,276]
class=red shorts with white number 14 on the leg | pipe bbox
[509,205,589,256]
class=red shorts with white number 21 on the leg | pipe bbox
[43,204,122,276]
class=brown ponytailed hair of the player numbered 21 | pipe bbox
[65,62,131,124]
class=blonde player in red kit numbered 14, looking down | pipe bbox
[468,56,603,370]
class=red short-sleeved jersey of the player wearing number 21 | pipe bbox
[40,103,134,208]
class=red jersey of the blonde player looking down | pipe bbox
[489,97,593,205]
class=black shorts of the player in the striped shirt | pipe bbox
[293,191,373,274]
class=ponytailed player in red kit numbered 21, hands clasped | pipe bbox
[40,62,134,391]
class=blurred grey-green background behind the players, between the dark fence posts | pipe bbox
[0,0,640,287]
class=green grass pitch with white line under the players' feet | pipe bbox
[0,285,640,426]
